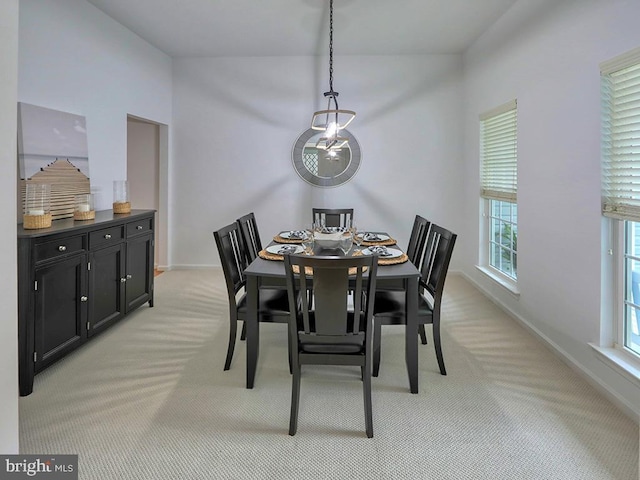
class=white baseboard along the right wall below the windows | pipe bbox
[450,271,640,423]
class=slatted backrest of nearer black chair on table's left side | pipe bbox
[213,222,247,305]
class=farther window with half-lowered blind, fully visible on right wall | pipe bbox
[480,100,518,284]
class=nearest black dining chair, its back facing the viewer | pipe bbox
[284,255,378,438]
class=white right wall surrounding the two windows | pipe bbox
[458,0,640,415]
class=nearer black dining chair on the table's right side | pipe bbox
[373,223,457,377]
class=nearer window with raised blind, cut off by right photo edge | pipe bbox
[600,49,640,356]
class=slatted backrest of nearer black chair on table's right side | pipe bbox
[420,223,458,303]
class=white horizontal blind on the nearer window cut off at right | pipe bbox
[600,48,640,222]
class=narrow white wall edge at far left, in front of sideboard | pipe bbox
[0,0,18,454]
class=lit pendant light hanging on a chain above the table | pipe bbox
[311,0,356,151]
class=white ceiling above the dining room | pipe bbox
[88,0,516,57]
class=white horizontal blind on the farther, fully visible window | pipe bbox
[480,100,518,203]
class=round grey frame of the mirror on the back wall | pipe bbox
[291,128,362,187]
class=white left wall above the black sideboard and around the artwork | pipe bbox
[18,0,172,209]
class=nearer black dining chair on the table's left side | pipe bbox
[213,222,289,370]
